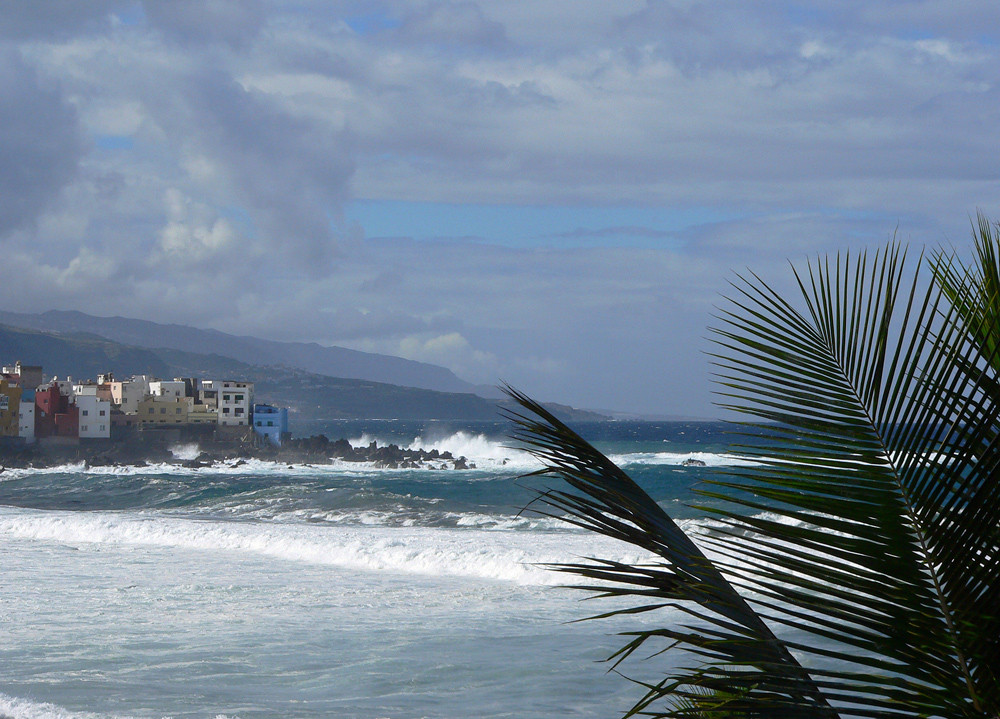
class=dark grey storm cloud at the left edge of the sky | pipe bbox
[0,47,83,239]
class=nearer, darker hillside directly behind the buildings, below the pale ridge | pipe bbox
[0,325,604,423]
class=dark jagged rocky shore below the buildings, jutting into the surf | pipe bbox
[0,435,476,472]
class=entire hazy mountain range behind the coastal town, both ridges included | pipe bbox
[0,312,605,421]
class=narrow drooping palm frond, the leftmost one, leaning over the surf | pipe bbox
[504,386,836,717]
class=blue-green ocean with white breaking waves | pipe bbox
[0,421,742,719]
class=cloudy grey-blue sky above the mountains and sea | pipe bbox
[0,0,1000,417]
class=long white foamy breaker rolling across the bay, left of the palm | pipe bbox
[0,508,652,584]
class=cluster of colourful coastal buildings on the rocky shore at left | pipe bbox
[0,362,288,445]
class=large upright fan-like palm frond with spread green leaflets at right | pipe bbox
[713,242,1000,716]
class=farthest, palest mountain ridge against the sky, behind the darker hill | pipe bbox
[0,310,497,396]
